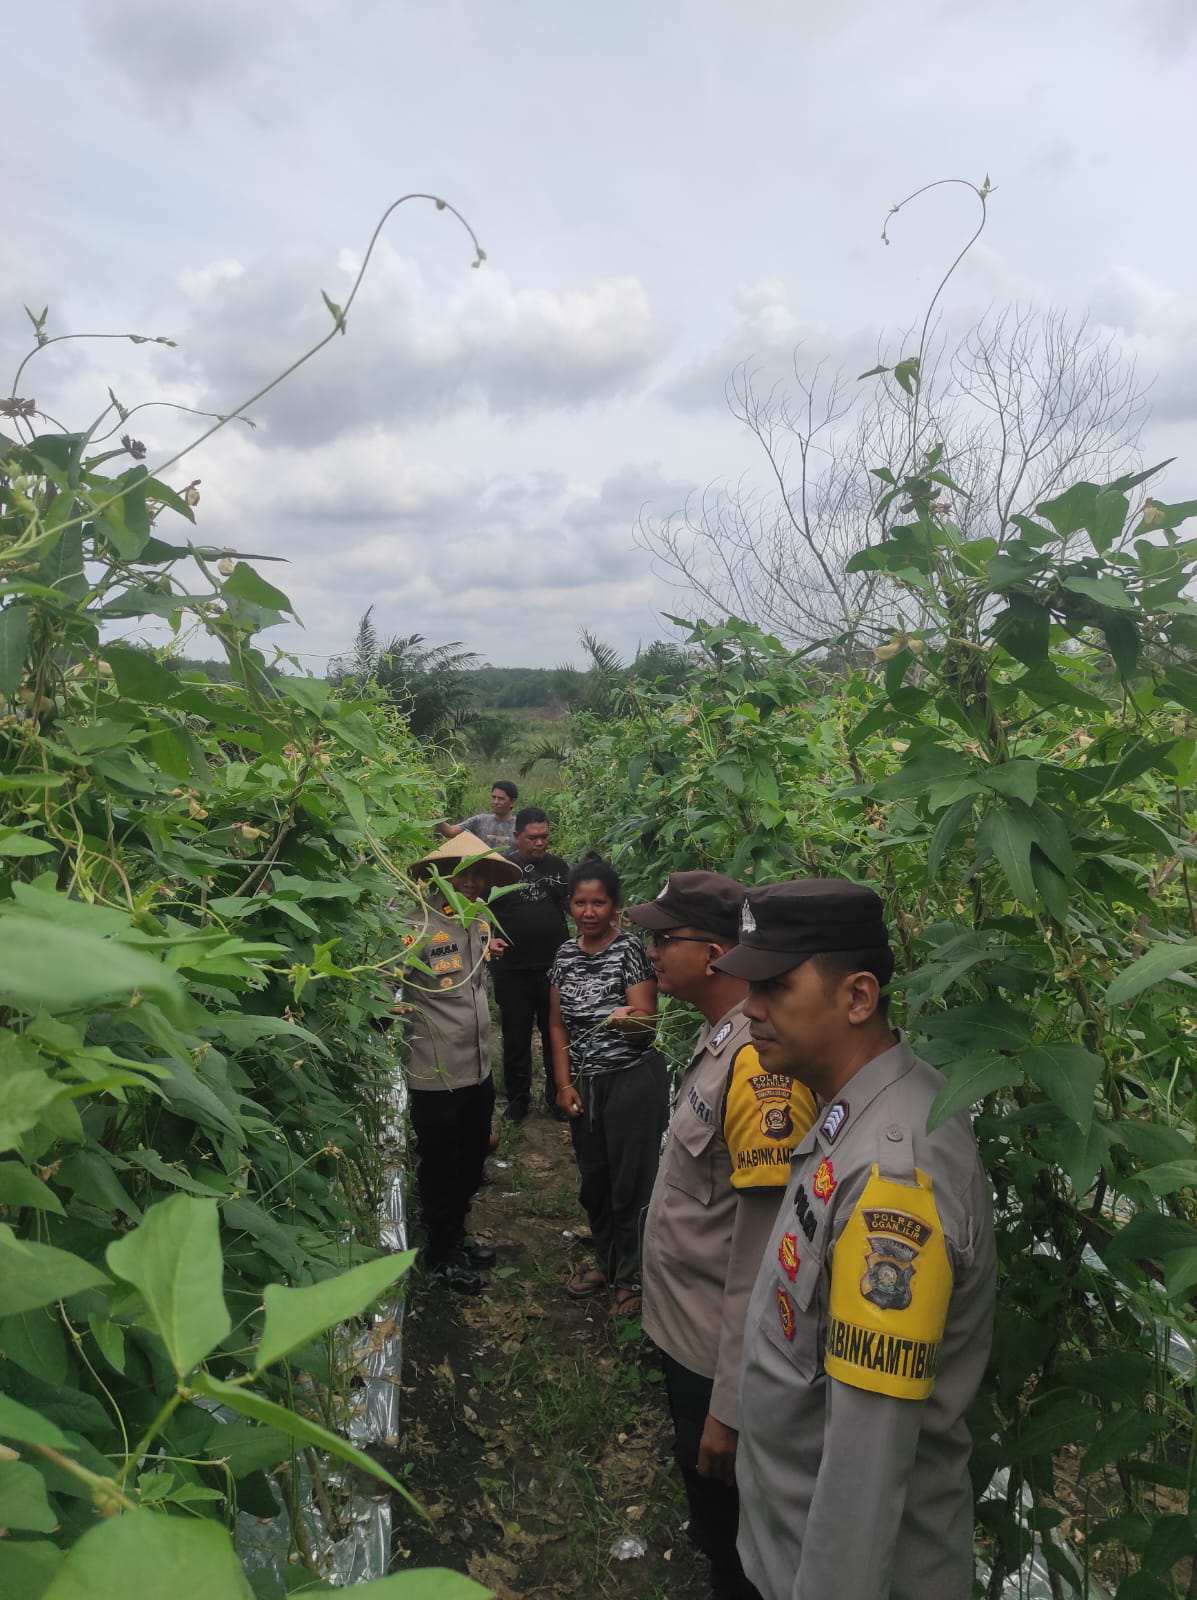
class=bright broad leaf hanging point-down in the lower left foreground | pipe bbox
[107,1195,232,1378]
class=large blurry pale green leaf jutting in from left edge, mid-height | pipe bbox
[0,915,182,1013]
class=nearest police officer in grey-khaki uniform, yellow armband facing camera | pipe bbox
[715,878,995,1600]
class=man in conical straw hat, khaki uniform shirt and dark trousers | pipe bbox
[403,832,520,1294]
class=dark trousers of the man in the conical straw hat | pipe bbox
[410,1077,494,1266]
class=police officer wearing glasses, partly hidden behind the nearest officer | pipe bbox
[627,872,815,1600]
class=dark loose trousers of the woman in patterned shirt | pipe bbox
[570,1050,669,1290]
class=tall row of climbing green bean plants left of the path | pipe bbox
[0,202,486,1600]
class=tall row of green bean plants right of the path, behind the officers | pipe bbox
[562,444,1197,1600]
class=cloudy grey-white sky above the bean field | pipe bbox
[9,0,1197,669]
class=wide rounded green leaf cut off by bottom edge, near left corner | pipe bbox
[42,1510,253,1600]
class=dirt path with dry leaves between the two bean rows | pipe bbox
[385,1112,709,1600]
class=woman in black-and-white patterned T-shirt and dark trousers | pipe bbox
[549,858,669,1315]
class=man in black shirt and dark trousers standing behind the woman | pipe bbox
[490,806,570,1122]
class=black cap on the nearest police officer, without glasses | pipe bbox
[712,878,890,982]
